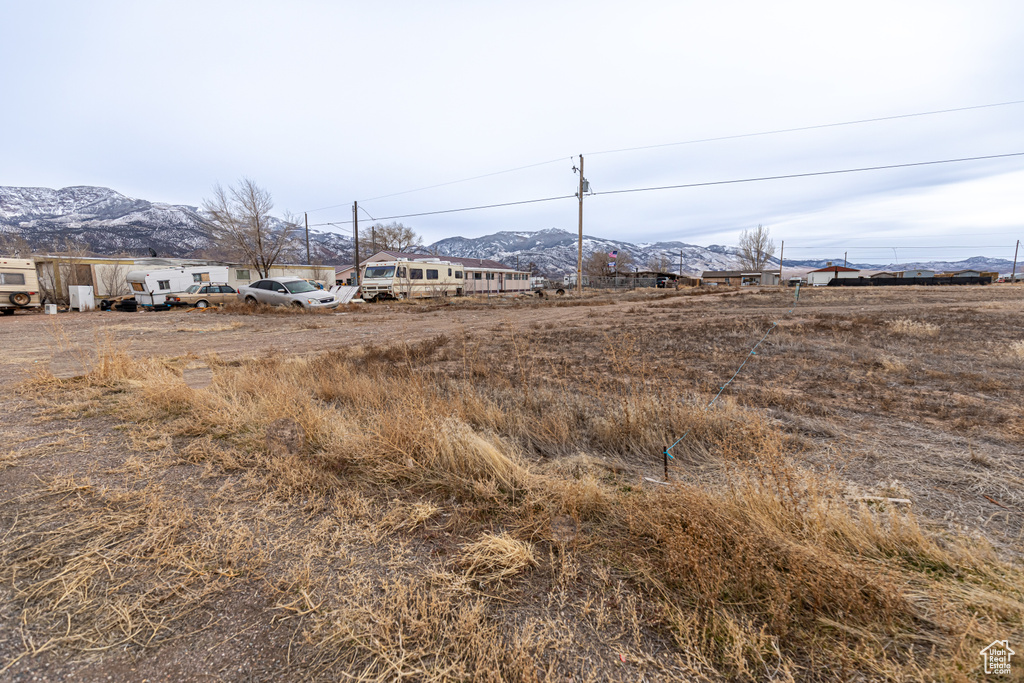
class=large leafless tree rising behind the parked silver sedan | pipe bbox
[203,178,299,278]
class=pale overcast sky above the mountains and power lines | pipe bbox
[0,0,1024,261]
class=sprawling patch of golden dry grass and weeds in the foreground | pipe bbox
[8,322,1024,680]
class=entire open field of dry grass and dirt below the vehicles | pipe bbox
[0,286,1024,681]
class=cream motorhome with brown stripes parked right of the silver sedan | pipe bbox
[359,259,466,301]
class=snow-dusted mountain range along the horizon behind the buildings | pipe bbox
[0,186,1012,276]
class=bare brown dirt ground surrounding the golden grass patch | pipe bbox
[0,286,1024,681]
